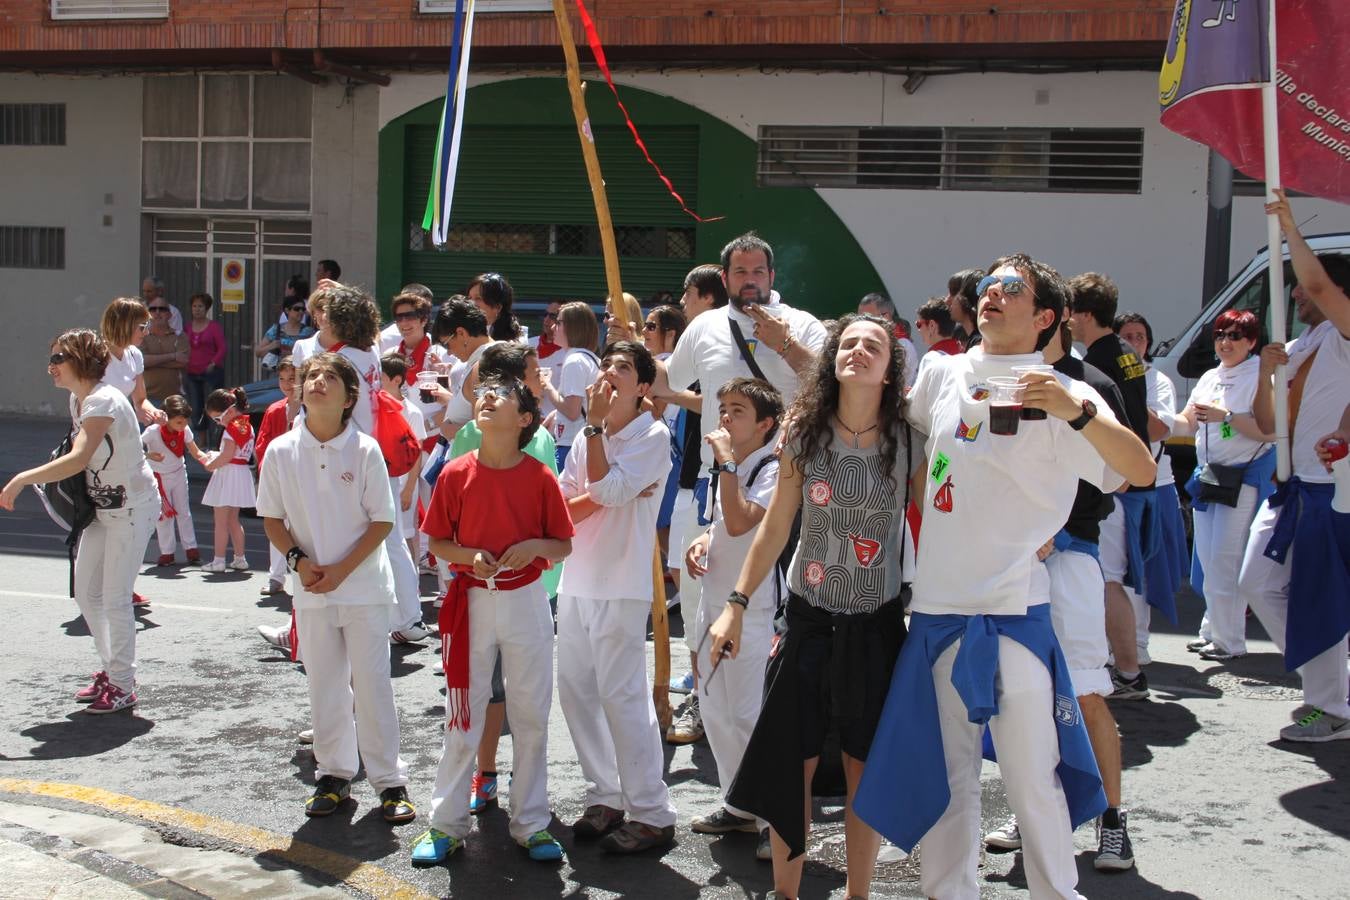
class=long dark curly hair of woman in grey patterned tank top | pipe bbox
[787,313,906,491]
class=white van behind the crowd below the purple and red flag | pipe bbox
[1153,232,1350,409]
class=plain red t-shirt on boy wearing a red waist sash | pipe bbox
[421,451,574,590]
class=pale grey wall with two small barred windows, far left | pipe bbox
[0,74,140,414]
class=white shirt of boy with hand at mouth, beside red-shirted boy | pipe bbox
[558,413,671,603]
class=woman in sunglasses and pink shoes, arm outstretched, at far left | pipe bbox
[0,327,159,712]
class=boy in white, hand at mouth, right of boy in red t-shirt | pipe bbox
[556,340,675,853]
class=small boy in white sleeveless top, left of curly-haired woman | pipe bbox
[684,378,783,834]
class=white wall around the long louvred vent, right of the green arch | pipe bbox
[379,70,1350,337]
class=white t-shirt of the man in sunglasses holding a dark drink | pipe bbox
[907,347,1123,615]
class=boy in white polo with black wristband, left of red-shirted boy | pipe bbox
[258,352,417,823]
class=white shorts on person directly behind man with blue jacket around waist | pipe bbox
[1045,551,1111,696]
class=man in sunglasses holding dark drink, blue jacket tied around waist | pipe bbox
[855,254,1156,897]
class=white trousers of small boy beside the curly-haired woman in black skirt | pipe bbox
[695,591,774,819]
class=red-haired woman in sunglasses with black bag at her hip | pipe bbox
[1172,309,1274,661]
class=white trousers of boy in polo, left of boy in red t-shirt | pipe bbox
[296,604,408,791]
